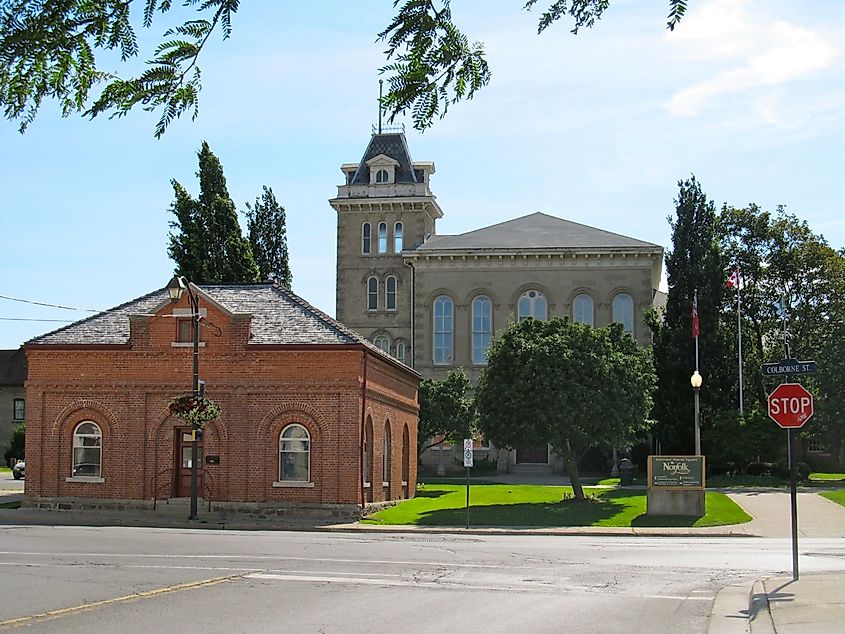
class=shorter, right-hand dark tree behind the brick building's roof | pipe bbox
[246,185,293,288]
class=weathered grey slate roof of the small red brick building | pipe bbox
[26,283,413,372]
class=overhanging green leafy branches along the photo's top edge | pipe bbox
[0,0,687,137]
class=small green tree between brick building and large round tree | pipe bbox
[417,369,475,457]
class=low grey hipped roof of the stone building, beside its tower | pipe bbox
[417,212,661,253]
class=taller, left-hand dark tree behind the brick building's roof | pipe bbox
[167,141,259,284]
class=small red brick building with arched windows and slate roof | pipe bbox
[25,284,420,509]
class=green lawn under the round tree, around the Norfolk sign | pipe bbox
[363,484,751,527]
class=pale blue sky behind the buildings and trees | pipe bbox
[0,0,845,348]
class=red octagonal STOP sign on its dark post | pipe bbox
[763,380,816,581]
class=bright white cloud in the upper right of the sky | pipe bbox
[666,0,841,118]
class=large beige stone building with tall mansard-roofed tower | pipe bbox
[329,131,663,472]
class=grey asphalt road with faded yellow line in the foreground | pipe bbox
[0,526,845,634]
